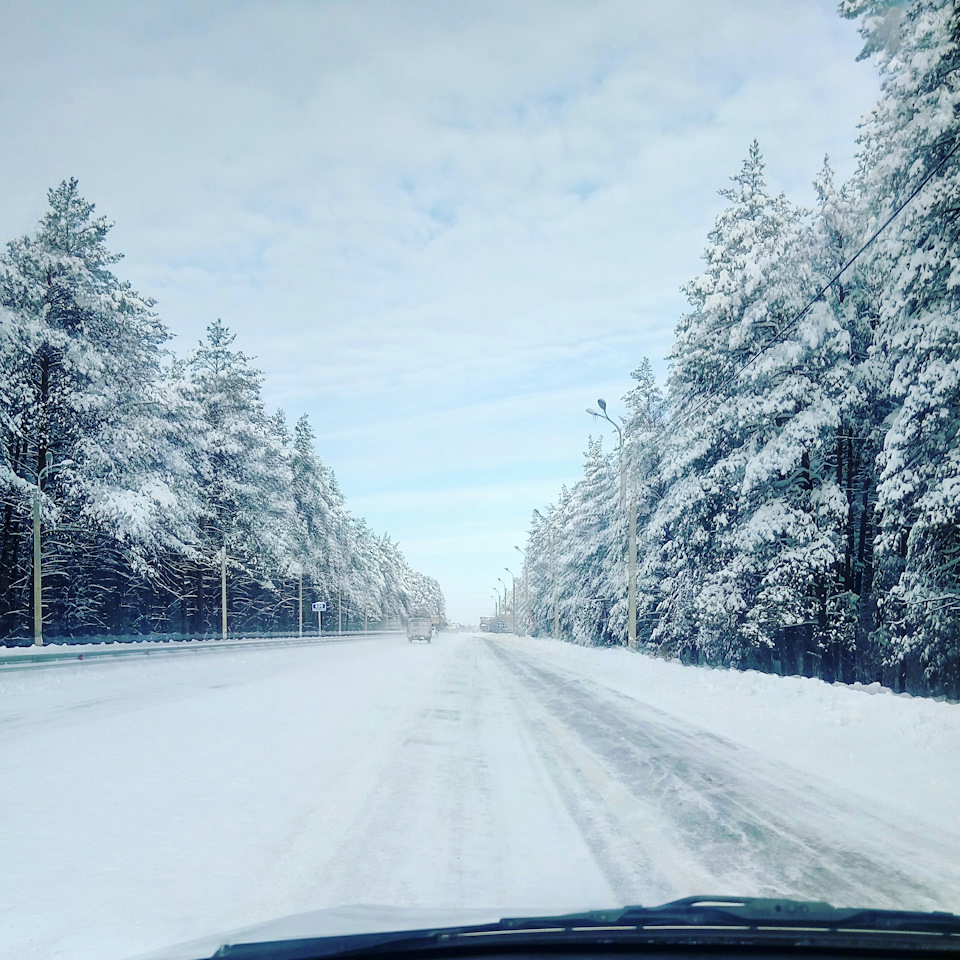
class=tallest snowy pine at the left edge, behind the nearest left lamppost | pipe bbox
[0,180,189,635]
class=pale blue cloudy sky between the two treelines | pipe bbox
[0,0,878,622]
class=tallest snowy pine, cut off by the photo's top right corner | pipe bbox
[841,0,960,695]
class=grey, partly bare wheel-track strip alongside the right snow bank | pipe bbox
[484,638,960,910]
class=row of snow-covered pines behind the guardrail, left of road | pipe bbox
[0,180,444,643]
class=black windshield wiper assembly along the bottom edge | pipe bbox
[211,897,960,960]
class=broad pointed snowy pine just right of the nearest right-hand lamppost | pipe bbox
[651,143,849,670]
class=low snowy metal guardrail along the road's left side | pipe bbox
[0,630,406,672]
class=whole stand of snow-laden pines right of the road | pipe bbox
[526,0,960,697]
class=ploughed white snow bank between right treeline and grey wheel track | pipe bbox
[498,636,960,833]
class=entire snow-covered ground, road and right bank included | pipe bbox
[0,634,960,960]
